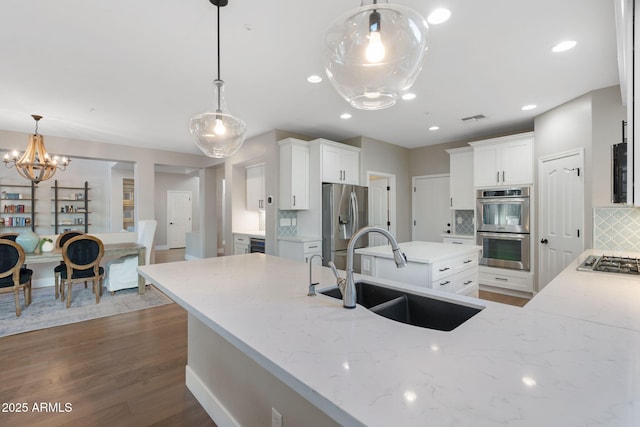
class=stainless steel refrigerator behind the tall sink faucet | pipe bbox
[322,183,369,272]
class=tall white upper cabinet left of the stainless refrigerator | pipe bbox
[278,138,309,210]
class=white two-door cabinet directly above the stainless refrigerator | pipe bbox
[316,140,360,185]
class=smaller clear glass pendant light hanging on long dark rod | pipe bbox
[190,0,247,158]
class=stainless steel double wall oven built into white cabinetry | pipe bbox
[476,187,531,271]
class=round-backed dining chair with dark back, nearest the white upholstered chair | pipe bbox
[60,234,104,308]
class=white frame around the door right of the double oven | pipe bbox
[532,147,593,292]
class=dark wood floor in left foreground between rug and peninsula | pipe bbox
[0,247,215,427]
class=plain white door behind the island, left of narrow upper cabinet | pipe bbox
[411,175,451,242]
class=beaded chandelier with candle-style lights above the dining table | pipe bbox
[3,114,70,184]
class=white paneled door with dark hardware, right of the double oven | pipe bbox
[538,150,584,291]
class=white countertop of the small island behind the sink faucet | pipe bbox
[356,241,482,264]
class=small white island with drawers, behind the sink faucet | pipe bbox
[356,241,482,298]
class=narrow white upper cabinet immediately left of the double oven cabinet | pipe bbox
[447,147,476,210]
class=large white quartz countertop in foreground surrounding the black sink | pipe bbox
[139,252,640,427]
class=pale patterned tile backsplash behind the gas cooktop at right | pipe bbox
[593,206,640,251]
